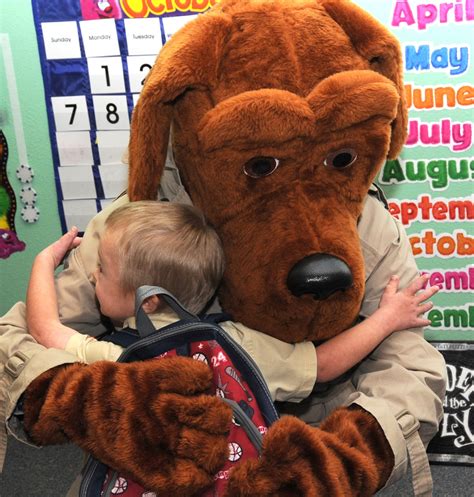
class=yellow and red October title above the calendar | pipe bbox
[120,0,219,18]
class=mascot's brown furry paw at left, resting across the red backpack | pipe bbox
[23,357,232,496]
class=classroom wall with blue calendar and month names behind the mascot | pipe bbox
[0,0,474,340]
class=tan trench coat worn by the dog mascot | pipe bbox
[0,166,446,495]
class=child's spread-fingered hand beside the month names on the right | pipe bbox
[378,275,439,331]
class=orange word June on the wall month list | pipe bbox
[405,84,474,110]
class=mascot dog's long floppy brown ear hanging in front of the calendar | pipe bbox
[128,13,228,201]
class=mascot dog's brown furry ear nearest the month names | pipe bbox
[318,0,408,159]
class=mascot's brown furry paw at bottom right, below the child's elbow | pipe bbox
[226,407,393,497]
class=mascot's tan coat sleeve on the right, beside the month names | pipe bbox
[349,193,446,485]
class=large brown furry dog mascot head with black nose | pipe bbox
[129,0,406,342]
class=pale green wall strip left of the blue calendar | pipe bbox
[0,0,61,315]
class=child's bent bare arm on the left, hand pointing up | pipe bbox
[26,227,81,349]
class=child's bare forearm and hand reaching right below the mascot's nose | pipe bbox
[316,275,439,383]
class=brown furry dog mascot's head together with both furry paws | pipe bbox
[17,0,440,497]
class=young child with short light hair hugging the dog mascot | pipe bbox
[27,201,438,392]
